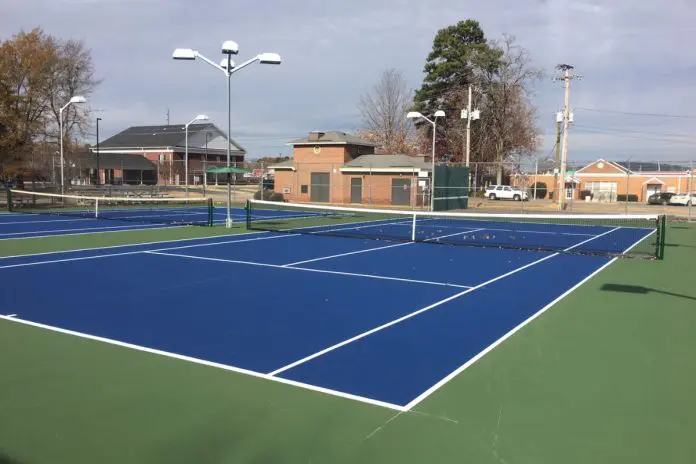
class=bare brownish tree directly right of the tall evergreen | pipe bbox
[474,35,543,183]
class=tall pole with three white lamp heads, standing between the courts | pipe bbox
[172,40,280,228]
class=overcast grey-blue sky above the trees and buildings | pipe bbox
[0,0,696,162]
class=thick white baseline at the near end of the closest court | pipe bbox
[0,316,405,411]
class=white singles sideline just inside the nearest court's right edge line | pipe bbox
[268,227,619,375]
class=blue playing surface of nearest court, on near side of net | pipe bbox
[0,214,652,410]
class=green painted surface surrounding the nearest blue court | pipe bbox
[0,223,696,464]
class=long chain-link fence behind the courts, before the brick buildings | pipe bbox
[0,154,696,219]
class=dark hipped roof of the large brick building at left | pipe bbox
[99,123,246,153]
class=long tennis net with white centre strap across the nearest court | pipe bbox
[247,200,665,259]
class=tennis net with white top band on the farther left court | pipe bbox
[7,190,213,226]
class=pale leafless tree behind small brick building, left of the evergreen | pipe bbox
[358,69,417,153]
